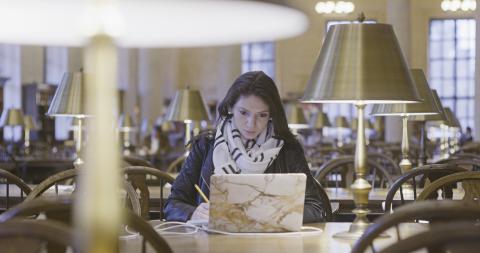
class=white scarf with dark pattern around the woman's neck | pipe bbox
[213,118,283,174]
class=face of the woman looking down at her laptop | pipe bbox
[232,95,270,139]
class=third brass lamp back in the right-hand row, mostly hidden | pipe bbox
[409,89,448,166]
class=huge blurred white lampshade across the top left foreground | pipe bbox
[0,0,308,47]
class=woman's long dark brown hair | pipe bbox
[218,71,295,143]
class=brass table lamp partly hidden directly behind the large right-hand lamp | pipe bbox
[371,69,439,173]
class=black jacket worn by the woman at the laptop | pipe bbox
[164,133,325,223]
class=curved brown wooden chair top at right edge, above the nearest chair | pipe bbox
[417,171,480,204]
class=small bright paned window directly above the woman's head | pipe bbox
[242,42,275,79]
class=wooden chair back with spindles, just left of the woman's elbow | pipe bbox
[123,166,175,219]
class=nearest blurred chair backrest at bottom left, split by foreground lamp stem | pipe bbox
[0,197,173,253]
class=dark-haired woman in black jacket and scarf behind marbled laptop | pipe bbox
[165,71,325,223]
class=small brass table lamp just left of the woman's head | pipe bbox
[165,87,210,148]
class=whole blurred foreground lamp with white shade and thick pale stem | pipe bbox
[0,0,308,252]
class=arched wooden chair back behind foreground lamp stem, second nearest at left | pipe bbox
[25,169,141,214]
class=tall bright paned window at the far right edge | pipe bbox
[428,19,475,129]
